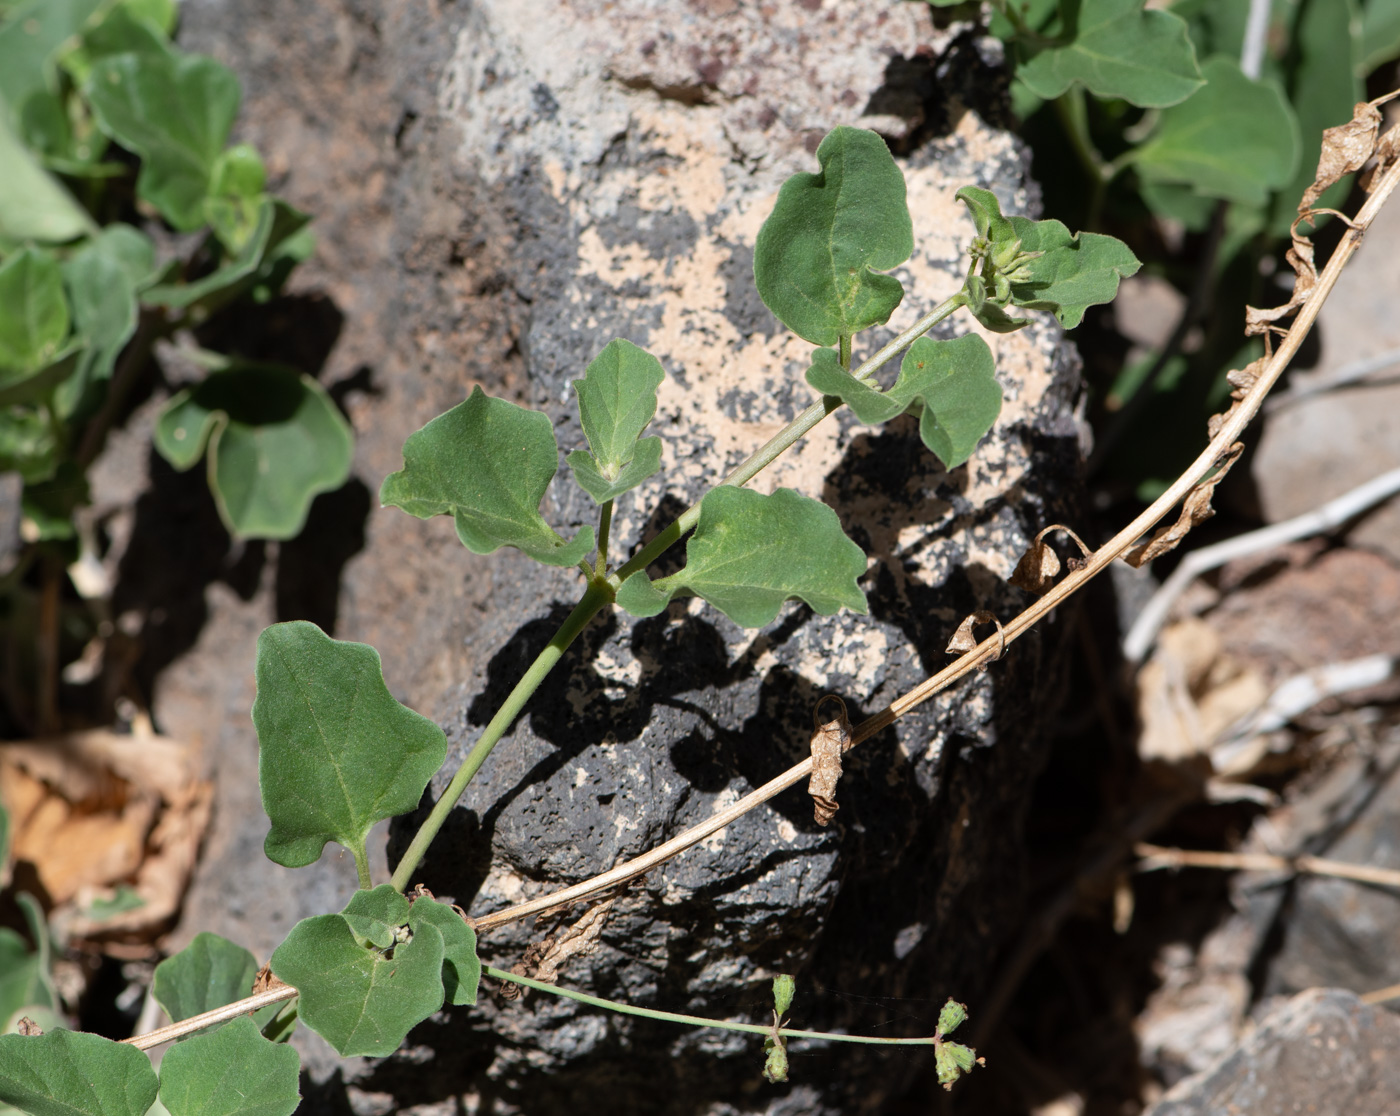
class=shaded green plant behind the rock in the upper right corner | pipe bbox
[917,0,1400,500]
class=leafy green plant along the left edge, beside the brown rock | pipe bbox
[0,0,351,731]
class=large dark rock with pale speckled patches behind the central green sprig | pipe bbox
[162,0,1082,1116]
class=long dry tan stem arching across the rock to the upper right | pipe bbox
[117,102,1400,1050]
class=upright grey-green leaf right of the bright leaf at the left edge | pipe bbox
[55,224,155,416]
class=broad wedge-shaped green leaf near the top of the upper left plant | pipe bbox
[84,53,239,232]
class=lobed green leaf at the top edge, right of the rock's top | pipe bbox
[1016,0,1201,108]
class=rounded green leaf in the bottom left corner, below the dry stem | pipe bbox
[0,1031,160,1116]
